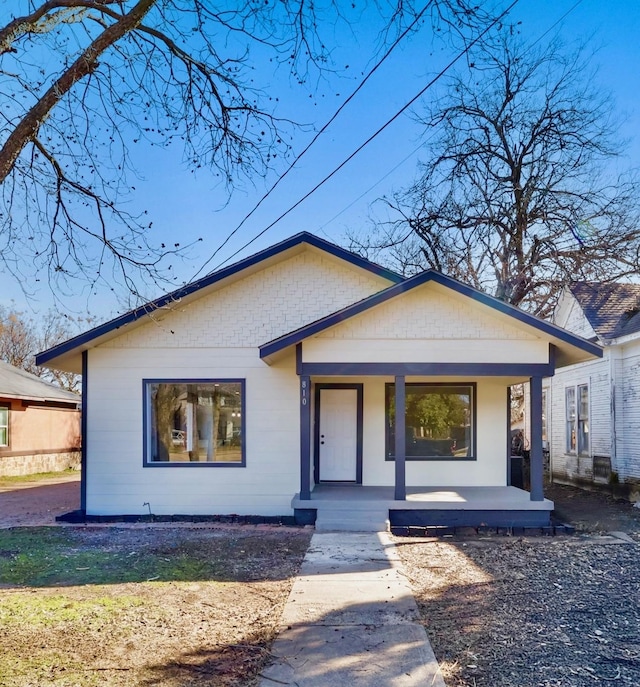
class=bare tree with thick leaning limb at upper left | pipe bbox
[0,0,484,304]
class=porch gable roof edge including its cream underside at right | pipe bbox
[260,270,603,367]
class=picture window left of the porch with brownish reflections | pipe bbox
[145,380,245,466]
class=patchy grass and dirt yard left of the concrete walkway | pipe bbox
[0,525,312,687]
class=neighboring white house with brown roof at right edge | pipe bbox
[543,283,640,500]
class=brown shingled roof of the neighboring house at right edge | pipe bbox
[569,282,640,341]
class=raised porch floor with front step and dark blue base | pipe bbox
[292,484,553,533]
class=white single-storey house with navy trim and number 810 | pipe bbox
[37,233,601,526]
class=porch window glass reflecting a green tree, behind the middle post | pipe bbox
[385,383,475,460]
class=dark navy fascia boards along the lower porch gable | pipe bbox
[260,270,603,359]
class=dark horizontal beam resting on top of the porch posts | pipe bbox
[302,363,555,377]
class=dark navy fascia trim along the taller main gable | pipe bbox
[36,231,404,365]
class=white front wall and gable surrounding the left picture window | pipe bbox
[87,249,388,515]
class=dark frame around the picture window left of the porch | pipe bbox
[142,377,247,468]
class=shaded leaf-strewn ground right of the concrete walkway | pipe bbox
[396,486,640,687]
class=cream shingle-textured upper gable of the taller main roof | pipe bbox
[103,250,389,349]
